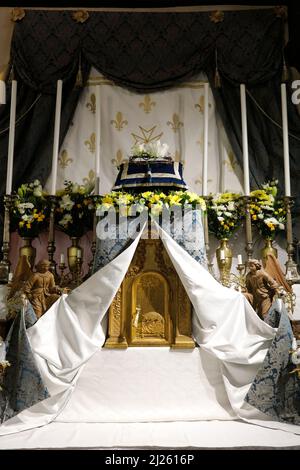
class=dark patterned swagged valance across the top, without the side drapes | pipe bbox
[12,9,283,93]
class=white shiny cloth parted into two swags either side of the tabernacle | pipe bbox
[0,221,300,435]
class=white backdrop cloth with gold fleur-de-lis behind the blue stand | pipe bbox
[46,69,242,194]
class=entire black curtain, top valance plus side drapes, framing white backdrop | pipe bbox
[0,8,300,250]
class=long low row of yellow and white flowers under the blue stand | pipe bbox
[96,191,206,216]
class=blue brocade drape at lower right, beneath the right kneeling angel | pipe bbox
[245,303,300,424]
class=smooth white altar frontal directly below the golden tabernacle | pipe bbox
[56,347,235,423]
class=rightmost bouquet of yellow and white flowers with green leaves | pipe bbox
[250,180,286,240]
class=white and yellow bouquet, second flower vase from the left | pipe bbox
[55,181,94,237]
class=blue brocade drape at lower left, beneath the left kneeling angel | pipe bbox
[0,304,50,422]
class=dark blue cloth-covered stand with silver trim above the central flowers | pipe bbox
[113,161,187,191]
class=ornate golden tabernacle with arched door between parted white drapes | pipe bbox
[104,239,195,349]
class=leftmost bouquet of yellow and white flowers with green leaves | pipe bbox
[11,180,50,238]
